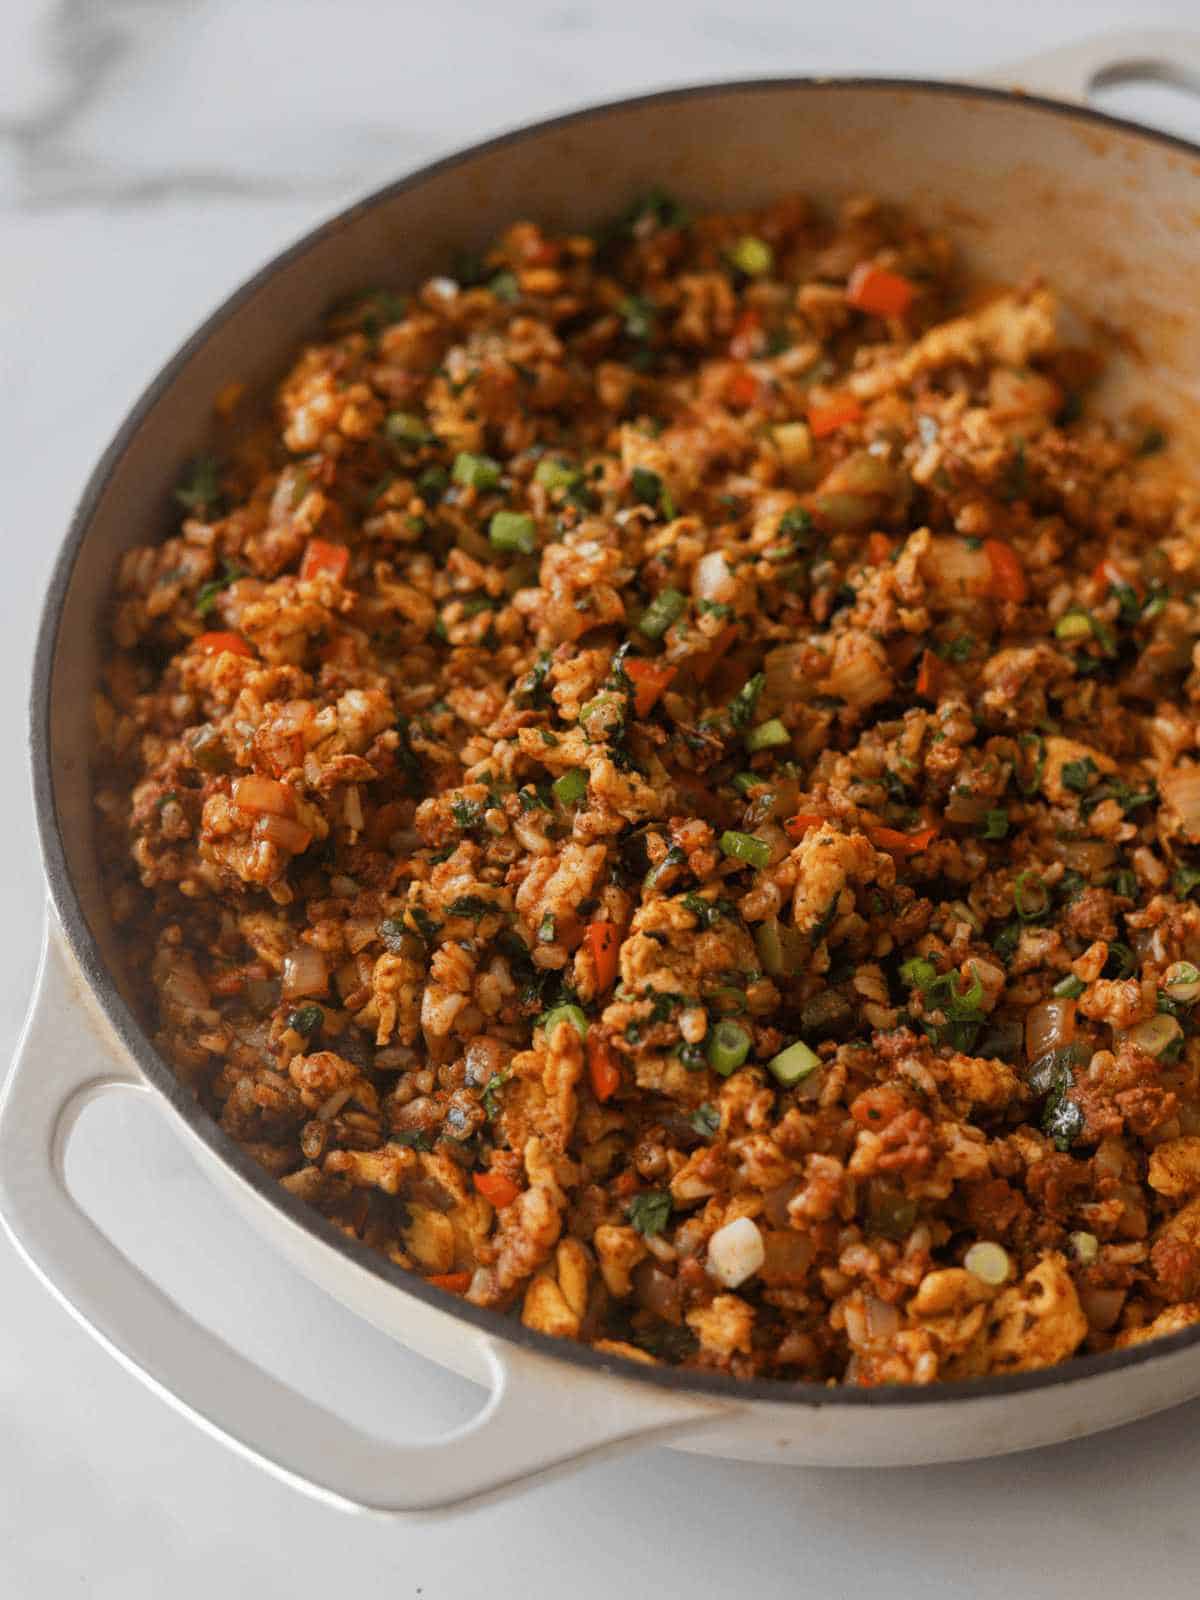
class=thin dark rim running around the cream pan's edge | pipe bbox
[29,75,1200,1410]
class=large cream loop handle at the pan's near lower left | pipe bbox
[0,918,734,1512]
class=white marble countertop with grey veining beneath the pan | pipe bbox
[0,0,1200,1600]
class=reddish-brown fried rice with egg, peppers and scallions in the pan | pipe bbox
[96,194,1200,1384]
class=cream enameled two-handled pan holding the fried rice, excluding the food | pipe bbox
[0,34,1200,1512]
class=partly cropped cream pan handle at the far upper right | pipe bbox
[974,27,1200,104]
